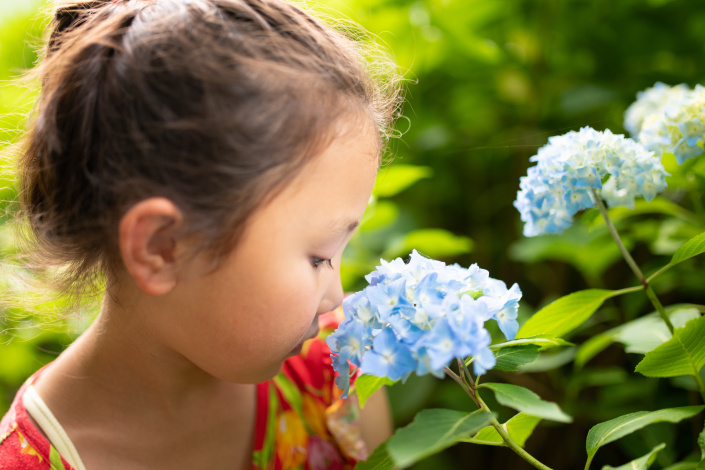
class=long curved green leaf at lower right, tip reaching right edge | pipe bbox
[585,406,705,468]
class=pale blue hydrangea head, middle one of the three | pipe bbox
[514,127,668,237]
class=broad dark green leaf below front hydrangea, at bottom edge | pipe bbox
[387,409,492,468]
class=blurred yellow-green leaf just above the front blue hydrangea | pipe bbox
[382,228,473,258]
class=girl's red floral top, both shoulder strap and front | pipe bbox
[0,311,367,470]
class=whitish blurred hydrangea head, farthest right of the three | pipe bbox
[625,85,705,164]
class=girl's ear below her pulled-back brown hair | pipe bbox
[119,197,183,295]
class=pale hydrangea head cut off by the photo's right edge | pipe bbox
[624,83,705,164]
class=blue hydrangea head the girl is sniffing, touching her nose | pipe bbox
[327,250,521,397]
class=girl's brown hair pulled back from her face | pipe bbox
[19,0,401,302]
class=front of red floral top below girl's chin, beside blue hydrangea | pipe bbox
[253,309,367,470]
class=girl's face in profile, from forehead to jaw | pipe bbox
[160,126,378,383]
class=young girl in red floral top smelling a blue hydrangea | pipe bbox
[0,0,399,470]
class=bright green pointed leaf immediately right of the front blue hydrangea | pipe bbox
[517,289,624,338]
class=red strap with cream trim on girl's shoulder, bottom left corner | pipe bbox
[0,369,73,470]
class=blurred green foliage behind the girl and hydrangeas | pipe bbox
[0,0,705,469]
